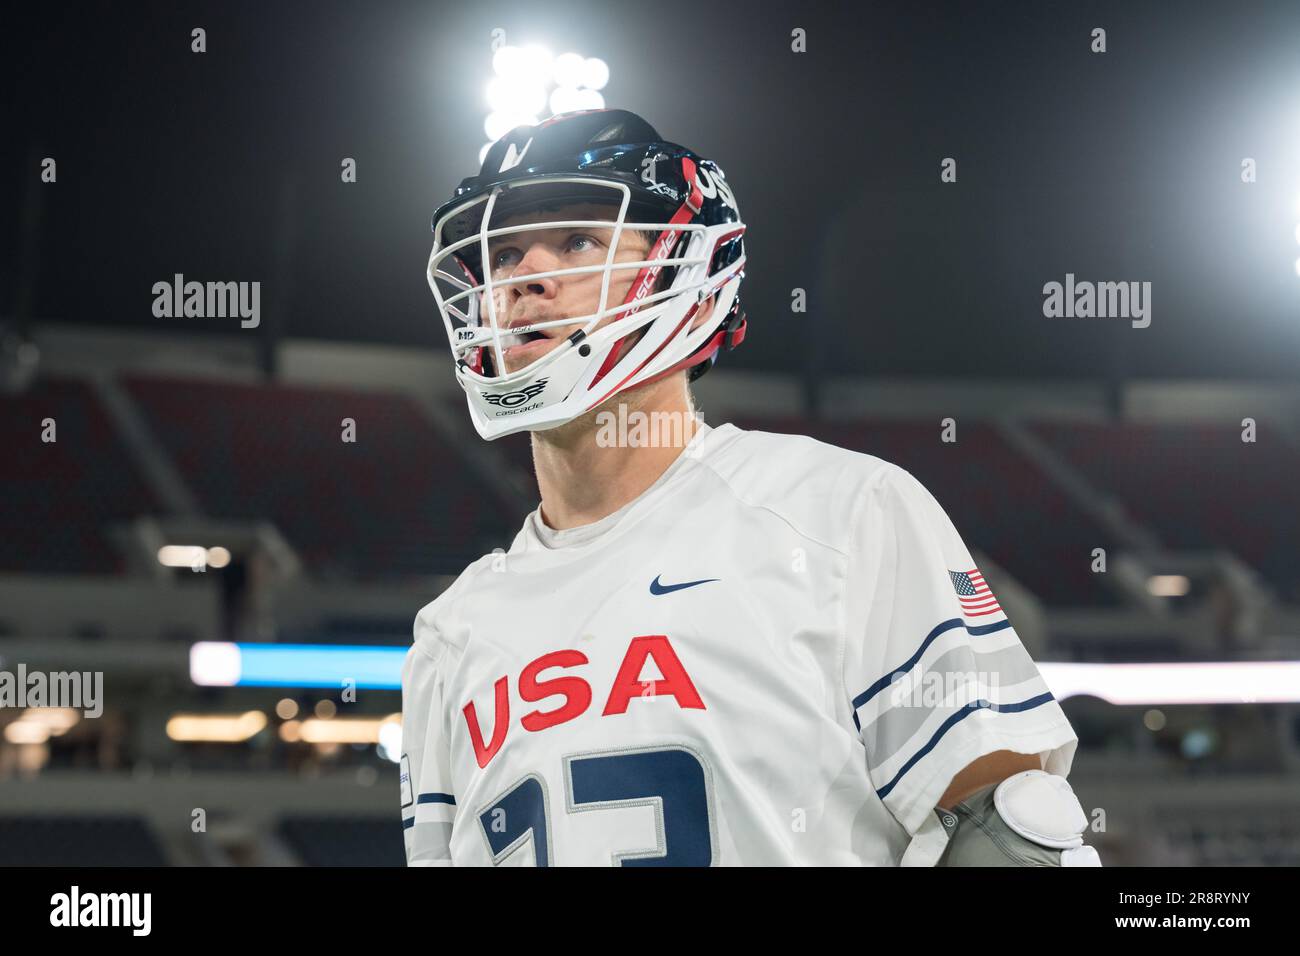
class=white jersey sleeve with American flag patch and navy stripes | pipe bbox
[845,466,1078,840]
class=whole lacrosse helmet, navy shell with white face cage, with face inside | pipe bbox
[426,109,745,440]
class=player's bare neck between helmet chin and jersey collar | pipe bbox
[533,376,697,531]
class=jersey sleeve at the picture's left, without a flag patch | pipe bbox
[400,641,456,866]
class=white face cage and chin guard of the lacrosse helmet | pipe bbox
[426,176,745,440]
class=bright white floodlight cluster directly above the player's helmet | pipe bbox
[478,43,610,164]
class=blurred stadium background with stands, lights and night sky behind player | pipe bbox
[0,1,1300,865]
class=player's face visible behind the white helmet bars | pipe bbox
[481,203,650,372]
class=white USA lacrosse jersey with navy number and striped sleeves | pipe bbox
[400,424,1078,866]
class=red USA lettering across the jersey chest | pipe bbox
[462,633,706,769]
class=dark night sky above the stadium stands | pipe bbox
[0,0,1300,380]
